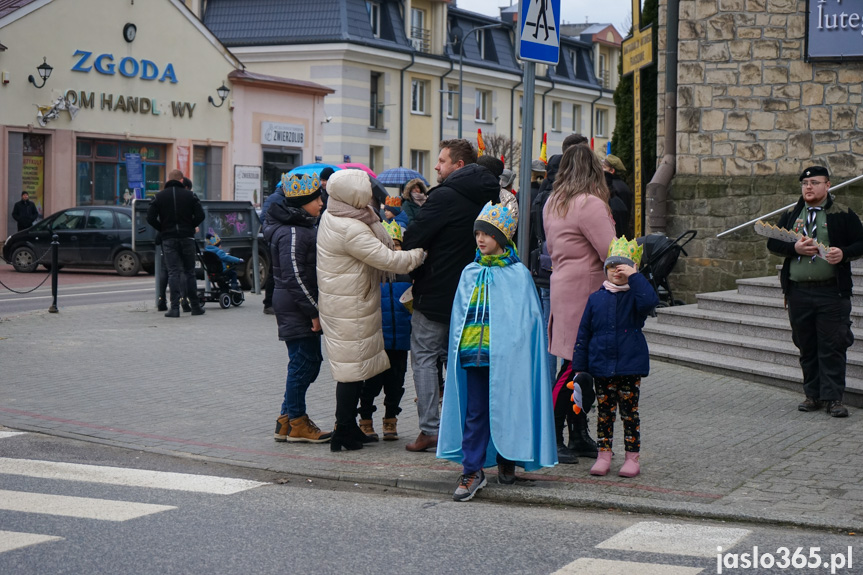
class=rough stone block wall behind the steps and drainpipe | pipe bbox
[657,0,863,302]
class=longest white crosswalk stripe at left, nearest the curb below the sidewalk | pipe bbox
[0,457,267,495]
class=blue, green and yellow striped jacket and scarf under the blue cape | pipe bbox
[458,246,520,367]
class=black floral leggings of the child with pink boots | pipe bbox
[593,375,641,453]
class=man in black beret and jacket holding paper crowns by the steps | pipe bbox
[767,166,863,417]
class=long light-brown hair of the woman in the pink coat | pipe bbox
[548,146,611,217]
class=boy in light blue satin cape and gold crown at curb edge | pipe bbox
[437,203,557,501]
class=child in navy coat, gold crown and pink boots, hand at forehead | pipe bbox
[572,236,659,477]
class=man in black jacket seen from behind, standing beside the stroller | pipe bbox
[147,170,204,317]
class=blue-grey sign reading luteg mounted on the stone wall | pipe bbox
[806,0,863,61]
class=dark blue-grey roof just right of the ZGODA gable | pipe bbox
[203,0,412,51]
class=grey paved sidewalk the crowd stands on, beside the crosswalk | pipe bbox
[0,294,863,531]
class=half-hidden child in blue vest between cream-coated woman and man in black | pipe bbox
[359,220,411,441]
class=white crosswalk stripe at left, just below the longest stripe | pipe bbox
[0,490,176,521]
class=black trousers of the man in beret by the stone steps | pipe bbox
[787,282,854,401]
